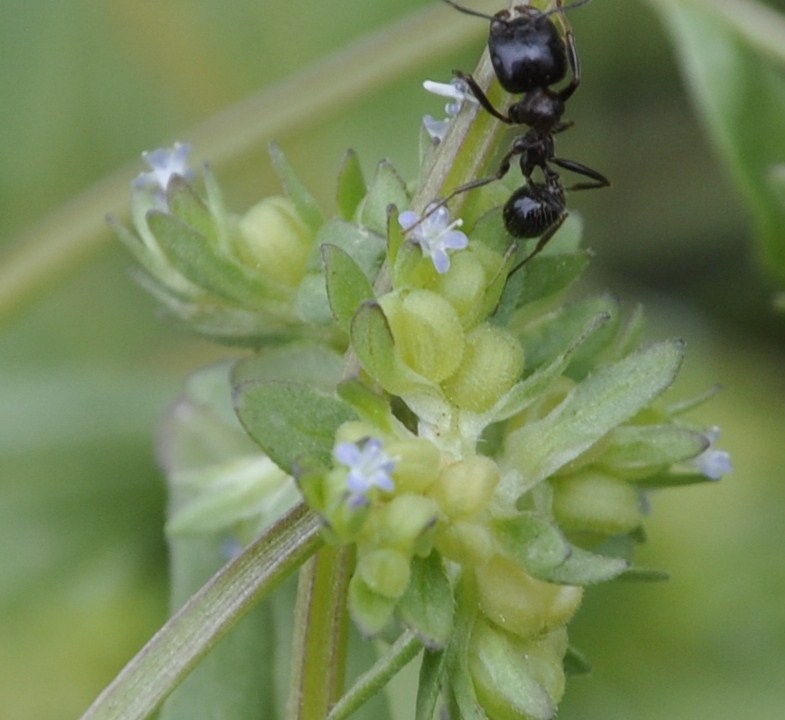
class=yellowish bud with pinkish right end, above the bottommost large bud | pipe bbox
[475,555,583,639]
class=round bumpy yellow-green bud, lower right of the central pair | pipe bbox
[442,324,523,412]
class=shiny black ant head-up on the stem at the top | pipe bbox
[439,0,610,274]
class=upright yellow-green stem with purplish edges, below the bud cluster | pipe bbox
[287,546,354,720]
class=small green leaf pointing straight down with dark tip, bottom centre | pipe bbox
[398,552,453,650]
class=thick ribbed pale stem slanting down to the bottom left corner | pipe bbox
[82,504,321,720]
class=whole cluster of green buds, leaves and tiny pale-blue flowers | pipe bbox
[120,125,730,720]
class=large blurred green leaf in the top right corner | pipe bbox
[654,0,785,279]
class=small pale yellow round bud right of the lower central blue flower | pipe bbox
[429,455,500,518]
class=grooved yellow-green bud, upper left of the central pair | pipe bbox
[379,290,464,382]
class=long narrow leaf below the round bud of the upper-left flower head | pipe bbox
[147,210,268,306]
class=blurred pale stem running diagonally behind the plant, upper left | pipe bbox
[0,3,482,321]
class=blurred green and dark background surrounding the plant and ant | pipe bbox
[0,0,785,720]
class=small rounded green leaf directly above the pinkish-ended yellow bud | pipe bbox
[493,513,571,575]
